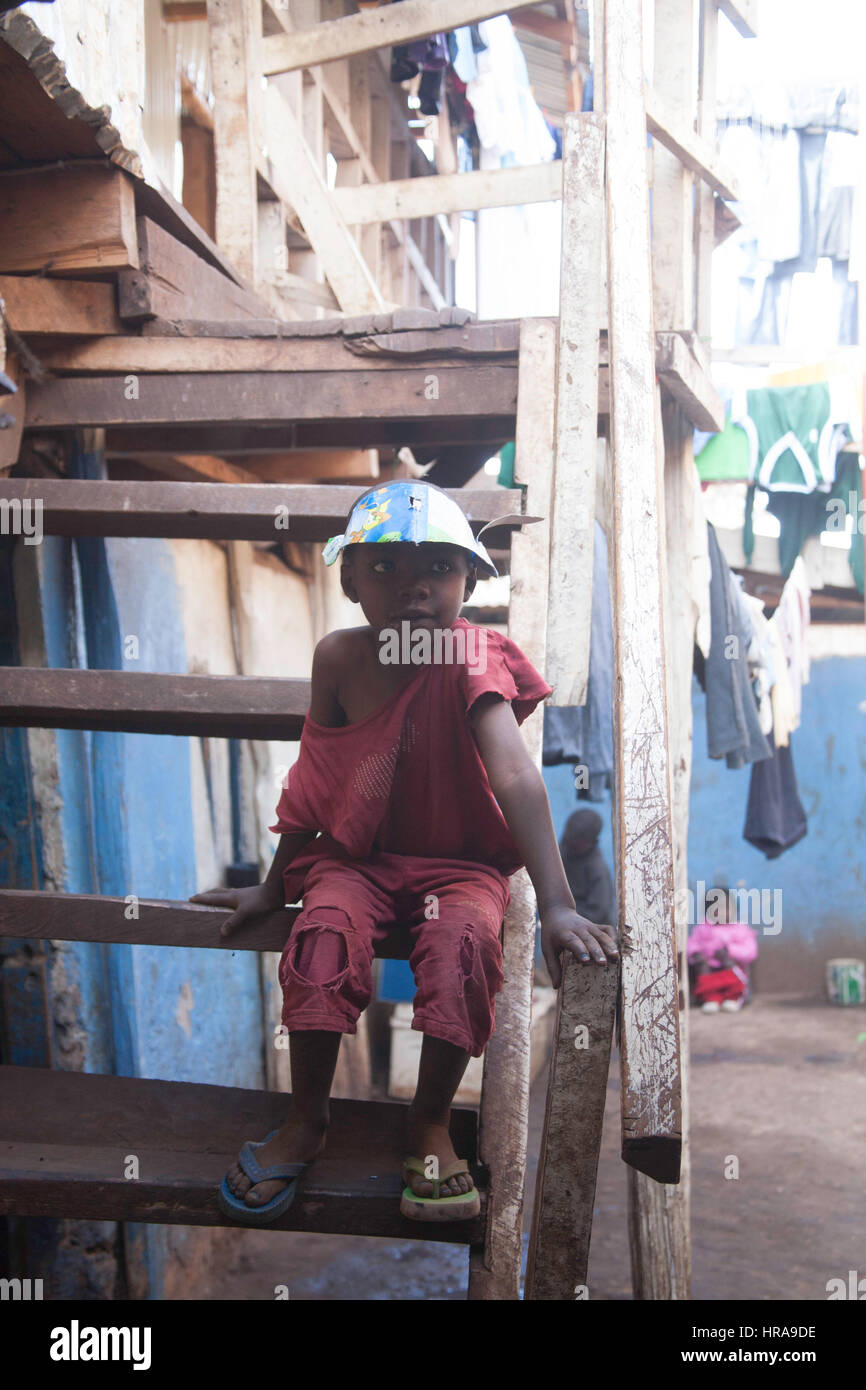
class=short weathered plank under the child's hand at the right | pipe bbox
[524,951,619,1301]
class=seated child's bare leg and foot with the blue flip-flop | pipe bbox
[225,1030,342,1207]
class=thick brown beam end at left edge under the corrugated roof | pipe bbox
[0,164,138,275]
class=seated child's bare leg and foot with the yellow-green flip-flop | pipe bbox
[409,1034,475,1197]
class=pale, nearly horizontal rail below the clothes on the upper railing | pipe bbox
[331,160,562,225]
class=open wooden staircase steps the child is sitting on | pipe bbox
[0,480,534,1297]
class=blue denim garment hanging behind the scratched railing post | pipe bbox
[542,521,613,801]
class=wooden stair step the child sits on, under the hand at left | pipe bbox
[0,888,414,960]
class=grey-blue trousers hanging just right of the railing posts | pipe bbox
[705,523,771,767]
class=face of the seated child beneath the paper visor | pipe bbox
[341,541,475,632]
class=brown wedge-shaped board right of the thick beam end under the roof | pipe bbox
[118,217,268,325]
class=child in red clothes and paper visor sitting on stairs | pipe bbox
[190,481,617,1225]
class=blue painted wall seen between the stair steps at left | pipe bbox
[0,453,265,1298]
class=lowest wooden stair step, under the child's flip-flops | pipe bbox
[0,1066,485,1244]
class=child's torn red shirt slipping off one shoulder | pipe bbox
[271,619,552,902]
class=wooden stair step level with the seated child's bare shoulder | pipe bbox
[0,666,310,741]
